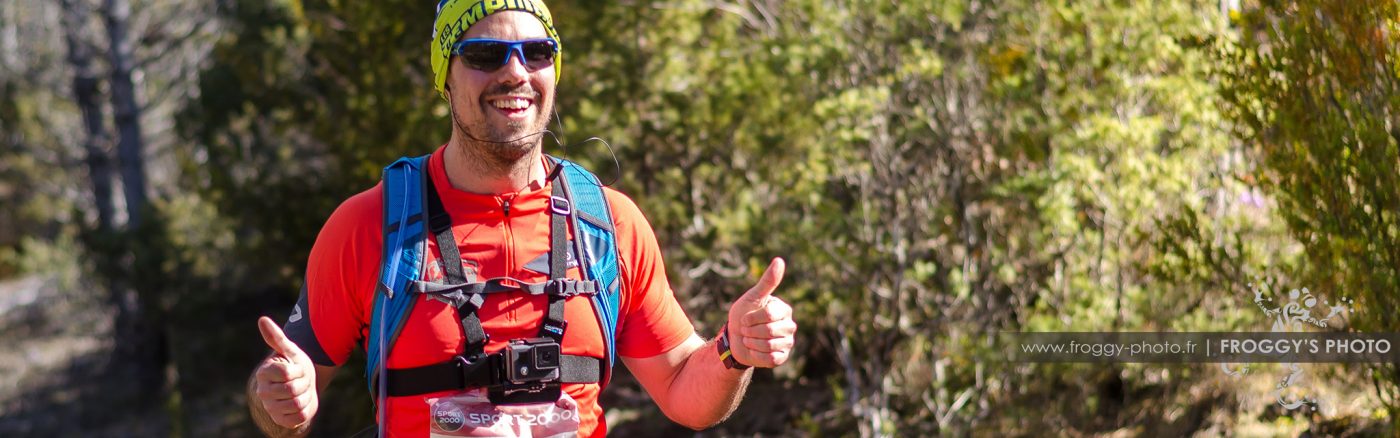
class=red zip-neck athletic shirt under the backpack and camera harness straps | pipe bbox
[287,147,694,437]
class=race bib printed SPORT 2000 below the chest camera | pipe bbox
[427,389,578,438]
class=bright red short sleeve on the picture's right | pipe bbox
[606,189,694,357]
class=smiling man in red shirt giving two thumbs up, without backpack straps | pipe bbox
[248,0,797,437]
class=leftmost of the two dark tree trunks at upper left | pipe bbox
[60,0,115,232]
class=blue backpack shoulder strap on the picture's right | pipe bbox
[554,158,620,386]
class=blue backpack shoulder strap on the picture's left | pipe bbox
[365,155,428,395]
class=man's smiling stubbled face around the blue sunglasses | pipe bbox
[447,11,554,164]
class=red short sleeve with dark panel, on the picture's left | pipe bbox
[284,186,384,367]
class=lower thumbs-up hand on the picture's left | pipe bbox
[253,316,319,428]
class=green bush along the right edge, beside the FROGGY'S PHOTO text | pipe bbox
[1221,0,1400,421]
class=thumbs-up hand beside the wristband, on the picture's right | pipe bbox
[729,257,797,368]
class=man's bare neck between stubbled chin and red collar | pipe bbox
[442,133,545,195]
